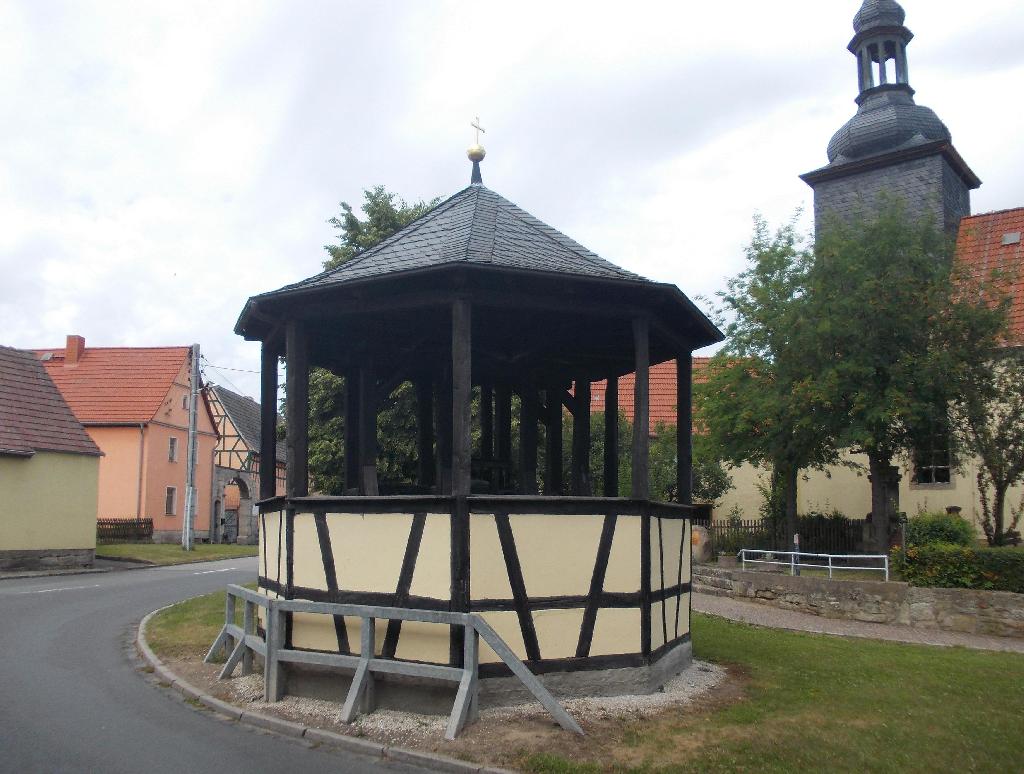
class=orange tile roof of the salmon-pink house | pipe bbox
[36,347,189,425]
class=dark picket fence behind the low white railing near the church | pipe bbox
[695,519,864,556]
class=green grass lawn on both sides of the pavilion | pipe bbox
[148,593,1024,774]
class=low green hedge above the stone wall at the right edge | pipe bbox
[892,545,1024,594]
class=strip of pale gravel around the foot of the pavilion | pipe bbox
[229,661,726,744]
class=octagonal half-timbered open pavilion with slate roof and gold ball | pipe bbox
[236,146,722,691]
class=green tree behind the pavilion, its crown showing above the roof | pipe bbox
[309,185,439,495]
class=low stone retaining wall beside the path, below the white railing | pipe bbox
[693,565,1024,639]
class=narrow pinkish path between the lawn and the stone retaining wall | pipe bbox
[693,593,1024,653]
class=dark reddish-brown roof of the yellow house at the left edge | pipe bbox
[0,346,101,457]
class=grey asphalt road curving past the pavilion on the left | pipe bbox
[0,558,418,774]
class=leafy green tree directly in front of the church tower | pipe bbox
[803,196,998,550]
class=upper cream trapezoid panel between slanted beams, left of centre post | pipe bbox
[327,513,413,593]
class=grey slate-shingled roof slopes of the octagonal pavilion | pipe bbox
[265,184,650,295]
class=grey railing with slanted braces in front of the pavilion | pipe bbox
[206,585,583,739]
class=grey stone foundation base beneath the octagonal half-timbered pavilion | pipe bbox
[285,641,693,715]
